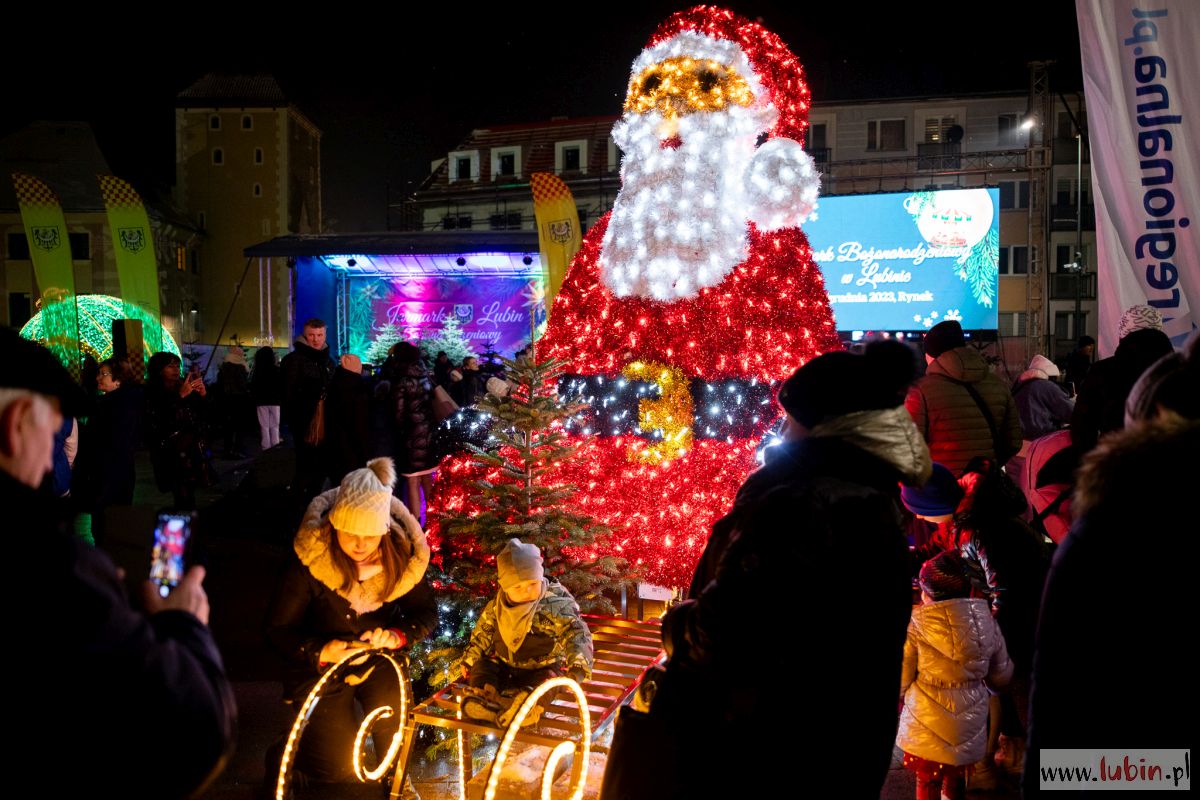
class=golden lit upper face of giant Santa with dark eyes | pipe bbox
[625,56,755,119]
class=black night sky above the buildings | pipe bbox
[0,0,1081,227]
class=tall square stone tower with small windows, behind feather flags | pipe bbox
[175,74,322,347]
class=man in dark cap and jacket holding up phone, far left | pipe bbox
[0,327,236,800]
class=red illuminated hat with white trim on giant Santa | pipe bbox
[634,6,810,143]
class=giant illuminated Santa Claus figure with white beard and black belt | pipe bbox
[439,6,840,587]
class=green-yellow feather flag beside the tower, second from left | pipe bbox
[96,175,162,353]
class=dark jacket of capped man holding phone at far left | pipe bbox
[0,471,236,800]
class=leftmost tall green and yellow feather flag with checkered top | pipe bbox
[12,173,80,377]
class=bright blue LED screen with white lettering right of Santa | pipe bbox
[804,188,1000,331]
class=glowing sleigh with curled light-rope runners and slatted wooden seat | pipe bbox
[275,615,664,800]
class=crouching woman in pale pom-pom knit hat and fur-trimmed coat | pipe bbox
[266,458,437,782]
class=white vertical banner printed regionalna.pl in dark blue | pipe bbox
[1075,0,1200,355]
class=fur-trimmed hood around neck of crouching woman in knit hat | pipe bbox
[293,489,430,614]
